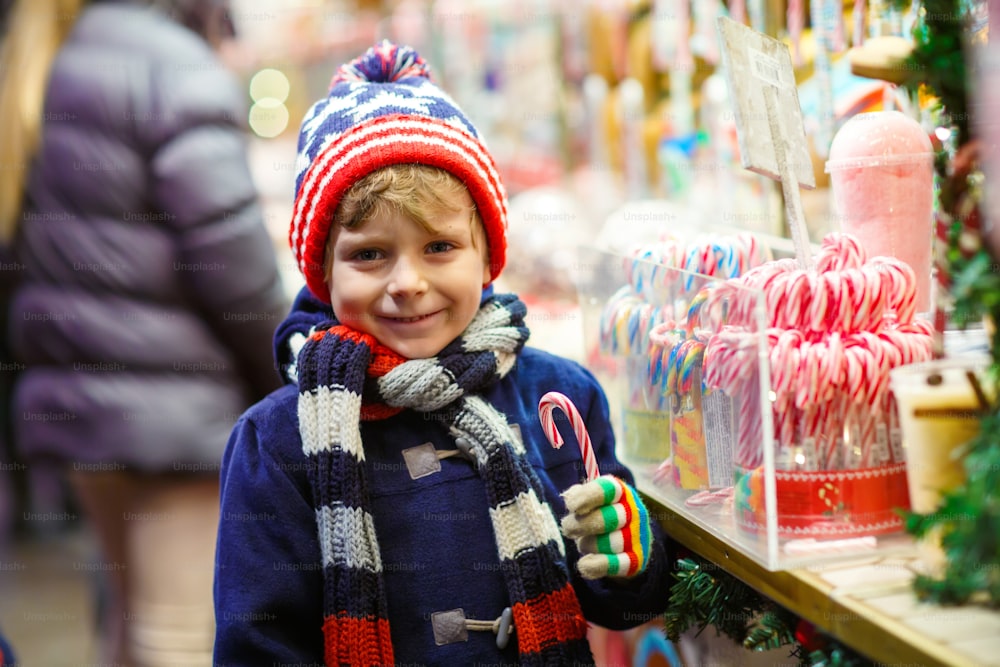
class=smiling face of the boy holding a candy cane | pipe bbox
[328,199,490,359]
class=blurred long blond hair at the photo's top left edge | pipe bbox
[0,0,84,243]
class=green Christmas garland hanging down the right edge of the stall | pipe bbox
[904,0,1000,607]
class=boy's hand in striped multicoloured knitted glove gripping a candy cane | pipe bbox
[562,475,653,579]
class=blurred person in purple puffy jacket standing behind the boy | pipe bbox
[0,0,287,665]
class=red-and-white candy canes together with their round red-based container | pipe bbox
[664,234,934,537]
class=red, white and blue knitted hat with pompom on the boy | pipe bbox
[288,41,507,303]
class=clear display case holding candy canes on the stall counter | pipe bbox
[575,247,923,570]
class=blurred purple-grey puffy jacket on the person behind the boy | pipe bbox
[7,3,287,473]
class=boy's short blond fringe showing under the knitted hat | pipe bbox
[323,163,485,275]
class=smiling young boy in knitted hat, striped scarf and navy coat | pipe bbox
[215,43,670,665]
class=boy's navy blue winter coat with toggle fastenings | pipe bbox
[215,290,670,666]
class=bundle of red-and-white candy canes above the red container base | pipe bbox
[686,234,933,470]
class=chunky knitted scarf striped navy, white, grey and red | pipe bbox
[297,294,593,666]
